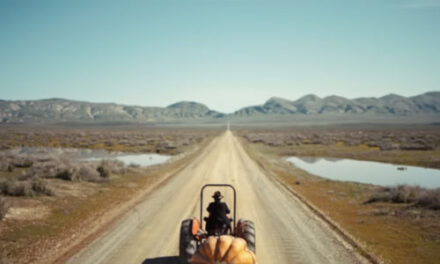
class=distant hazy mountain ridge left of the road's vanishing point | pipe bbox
[0,98,225,123]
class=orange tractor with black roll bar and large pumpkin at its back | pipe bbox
[179,184,257,264]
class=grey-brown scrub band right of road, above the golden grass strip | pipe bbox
[238,128,440,151]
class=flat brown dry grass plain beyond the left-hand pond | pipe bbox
[0,126,215,154]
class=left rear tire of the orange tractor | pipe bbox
[179,219,197,264]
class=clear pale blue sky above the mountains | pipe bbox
[0,0,440,112]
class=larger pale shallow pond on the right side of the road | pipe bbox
[287,157,440,188]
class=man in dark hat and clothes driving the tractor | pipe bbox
[206,191,231,235]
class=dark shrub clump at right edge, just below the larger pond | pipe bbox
[366,184,440,210]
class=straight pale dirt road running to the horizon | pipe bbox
[68,131,364,264]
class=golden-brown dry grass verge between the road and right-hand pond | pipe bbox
[243,134,440,263]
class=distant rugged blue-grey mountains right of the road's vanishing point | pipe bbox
[233,92,440,117]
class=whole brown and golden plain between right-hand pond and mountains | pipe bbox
[237,128,440,168]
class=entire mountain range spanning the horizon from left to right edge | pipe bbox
[0,92,440,123]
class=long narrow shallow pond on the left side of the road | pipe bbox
[5,147,171,166]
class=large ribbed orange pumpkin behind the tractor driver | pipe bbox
[191,235,257,264]
